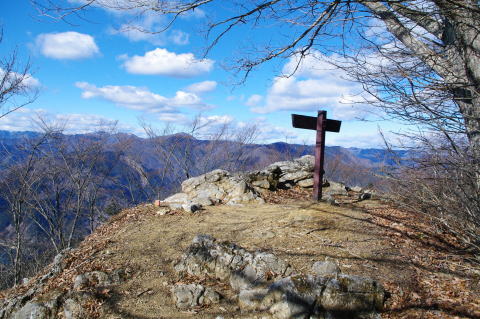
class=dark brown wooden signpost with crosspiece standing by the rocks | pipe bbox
[292,111,342,201]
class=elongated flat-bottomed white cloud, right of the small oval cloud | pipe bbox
[123,48,214,78]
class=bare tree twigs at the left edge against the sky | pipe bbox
[0,28,38,119]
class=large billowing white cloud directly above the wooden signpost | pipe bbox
[251,51,372,120]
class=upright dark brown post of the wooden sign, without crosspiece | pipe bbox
[313,111,327,201]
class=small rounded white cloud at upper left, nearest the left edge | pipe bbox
[35,31,100,60]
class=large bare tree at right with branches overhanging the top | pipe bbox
[32,0,480,254]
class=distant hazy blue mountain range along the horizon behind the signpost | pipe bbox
[0,131,406,239]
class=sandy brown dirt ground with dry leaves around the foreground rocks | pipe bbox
[4,194,480,319]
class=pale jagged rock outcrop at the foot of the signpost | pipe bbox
[160,155,368,213]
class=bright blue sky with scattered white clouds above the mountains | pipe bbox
[0,0,399,148]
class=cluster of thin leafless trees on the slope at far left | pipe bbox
[0,122,134,287]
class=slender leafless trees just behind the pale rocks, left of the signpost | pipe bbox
[139,114,258,198]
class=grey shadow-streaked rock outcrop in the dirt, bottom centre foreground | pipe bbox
[172,235,384,319]
